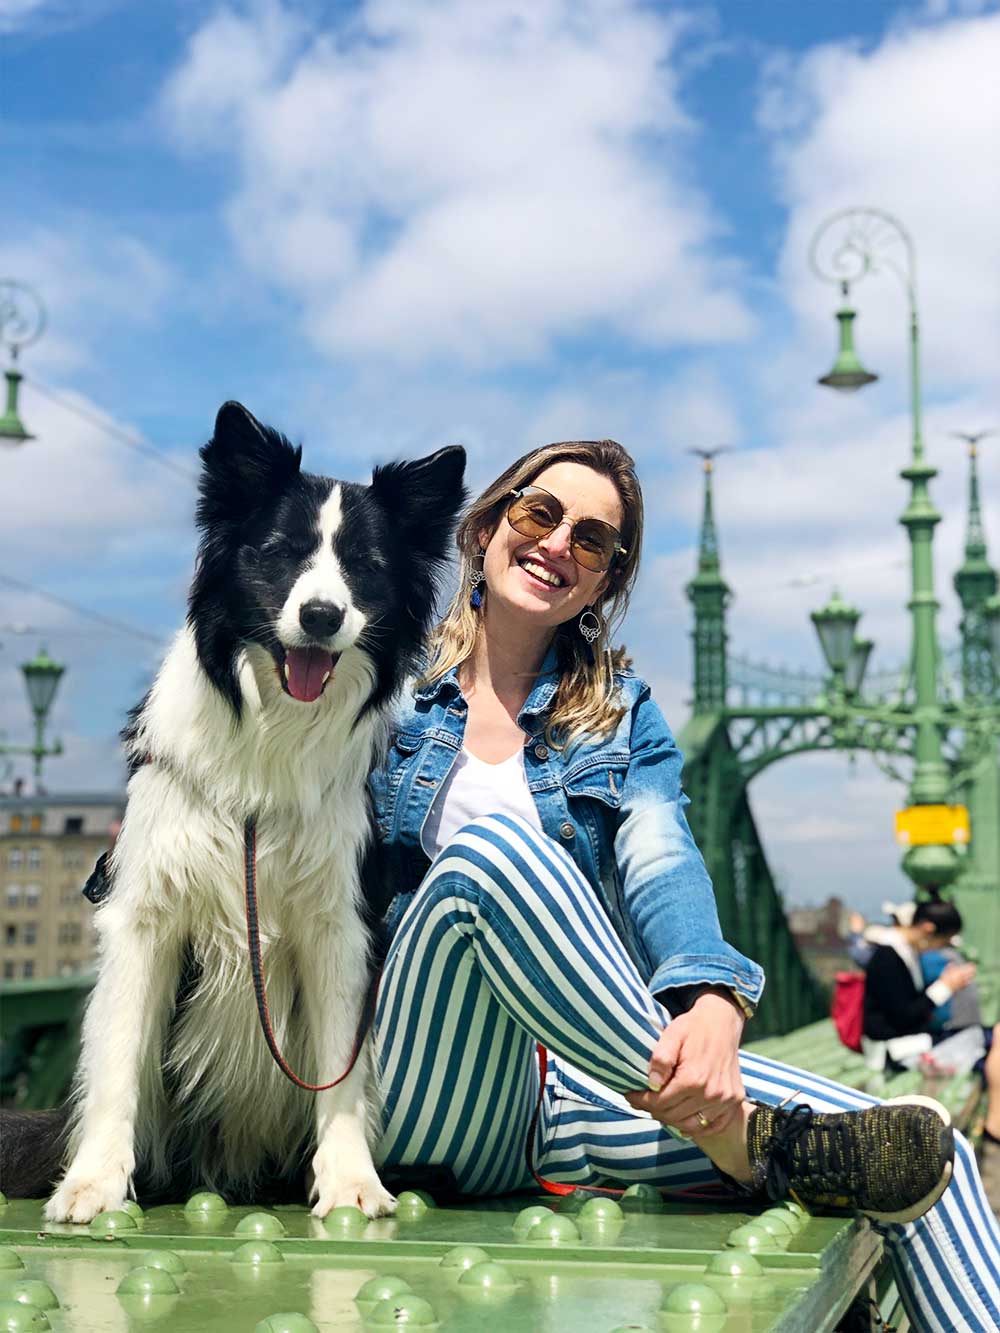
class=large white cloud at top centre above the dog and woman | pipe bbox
[163,0,751,365]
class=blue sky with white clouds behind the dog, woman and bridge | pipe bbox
[0,0,1000,905]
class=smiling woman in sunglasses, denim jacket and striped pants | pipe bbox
[373,440,1000,1330]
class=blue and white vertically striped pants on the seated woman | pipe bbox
[375,816,1000,1333]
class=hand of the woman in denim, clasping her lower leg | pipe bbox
[625,990,747,1138]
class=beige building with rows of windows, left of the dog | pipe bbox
[0,792,125,981]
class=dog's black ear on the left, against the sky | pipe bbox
[197,403,303,528]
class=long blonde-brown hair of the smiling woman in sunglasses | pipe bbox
[424,440,643,748]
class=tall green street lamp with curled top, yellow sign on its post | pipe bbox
[809,208,960,885]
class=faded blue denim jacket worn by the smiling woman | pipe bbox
[371,648,764,1008]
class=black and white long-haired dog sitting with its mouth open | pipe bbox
[45,403,465,1222]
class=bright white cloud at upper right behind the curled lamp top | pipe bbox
[760,13,1000,392]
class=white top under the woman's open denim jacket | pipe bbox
[420,746,541,860]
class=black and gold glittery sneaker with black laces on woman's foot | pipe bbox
[747,1097,955,1222]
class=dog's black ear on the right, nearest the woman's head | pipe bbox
[372,444,465,559]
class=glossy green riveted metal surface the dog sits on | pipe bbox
[0,1194,881,1333]
